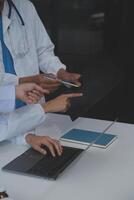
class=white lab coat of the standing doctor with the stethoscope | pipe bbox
[0,0,65,84]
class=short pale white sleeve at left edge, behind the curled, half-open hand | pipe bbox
[0,85,15,113]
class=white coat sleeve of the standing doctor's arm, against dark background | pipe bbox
[33,3,66,74]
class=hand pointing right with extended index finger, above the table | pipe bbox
[42,93,82,113]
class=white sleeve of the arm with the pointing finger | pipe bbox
[0,104,46,141]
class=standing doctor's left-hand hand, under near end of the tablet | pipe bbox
[19,74,60,92]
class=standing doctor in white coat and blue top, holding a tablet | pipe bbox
[0,0,80,88]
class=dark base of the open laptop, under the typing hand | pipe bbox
[2,146,84,179]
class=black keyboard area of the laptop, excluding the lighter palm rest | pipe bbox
[27,146,83,178]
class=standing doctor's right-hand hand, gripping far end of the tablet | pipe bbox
[57,69,81,86]
